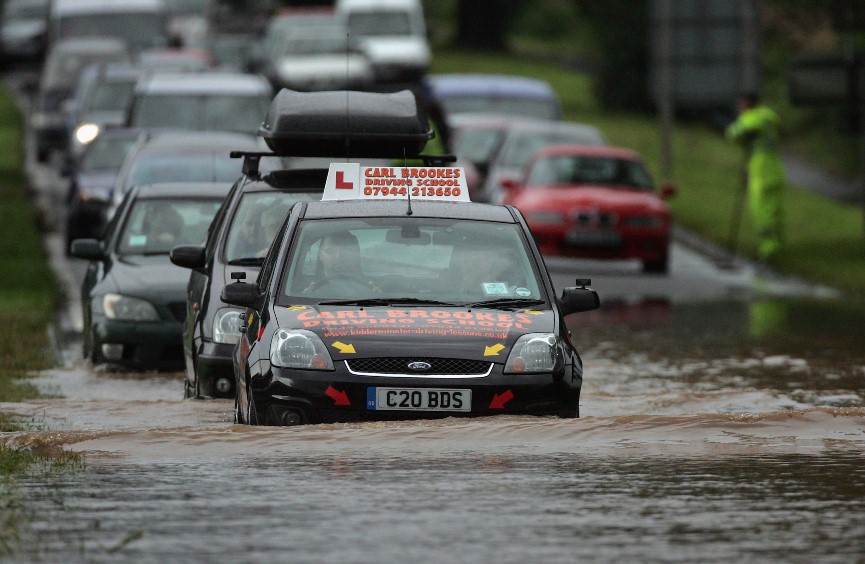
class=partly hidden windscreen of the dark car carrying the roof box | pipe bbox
[224,191,321,264]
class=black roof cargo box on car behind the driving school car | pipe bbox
[258,88,433,158]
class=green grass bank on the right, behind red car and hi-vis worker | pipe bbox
[432,50,865,300]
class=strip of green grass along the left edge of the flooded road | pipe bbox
[0,82,83,557]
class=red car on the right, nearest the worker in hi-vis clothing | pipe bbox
[502,145,675,273]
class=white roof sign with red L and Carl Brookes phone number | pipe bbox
[322,163,471,202]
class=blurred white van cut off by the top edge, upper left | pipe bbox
[49,0,169,53]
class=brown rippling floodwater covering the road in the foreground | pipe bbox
[0,299,865,563]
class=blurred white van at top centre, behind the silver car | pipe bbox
[335,0,430,85]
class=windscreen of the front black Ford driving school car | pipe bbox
[277,217,545,304]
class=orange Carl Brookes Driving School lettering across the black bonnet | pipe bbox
[290,308,548,340]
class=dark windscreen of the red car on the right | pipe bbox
[527,155,653,190]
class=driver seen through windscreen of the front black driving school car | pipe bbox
[303,231,381,293]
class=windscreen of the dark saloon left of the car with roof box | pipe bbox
[117,198,222,256]
